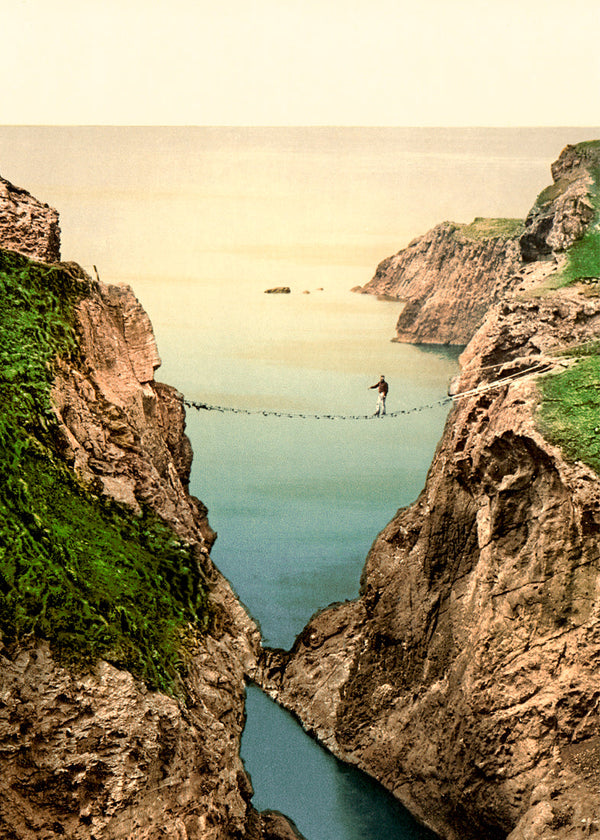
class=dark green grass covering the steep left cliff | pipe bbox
[0,252,210,693]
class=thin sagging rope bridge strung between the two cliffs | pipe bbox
[183,360,560,420]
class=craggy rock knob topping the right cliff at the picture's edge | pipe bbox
[519,143,600,262]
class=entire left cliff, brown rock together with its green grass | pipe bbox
[0,177,297,840]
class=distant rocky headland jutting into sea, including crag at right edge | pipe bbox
[354,144,597,345]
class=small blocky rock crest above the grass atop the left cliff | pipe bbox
[0,177,60,262]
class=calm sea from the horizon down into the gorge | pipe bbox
[0,126,600,840]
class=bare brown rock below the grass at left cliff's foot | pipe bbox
[0,640,255,840]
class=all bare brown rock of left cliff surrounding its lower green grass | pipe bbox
[0,264,296,840]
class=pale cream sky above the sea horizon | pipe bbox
[0,0,600,126]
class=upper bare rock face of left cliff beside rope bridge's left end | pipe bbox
[53,264,214,550]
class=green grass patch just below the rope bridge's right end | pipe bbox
[537,341,600,473]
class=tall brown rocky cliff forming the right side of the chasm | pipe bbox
[260,144,600,840]
